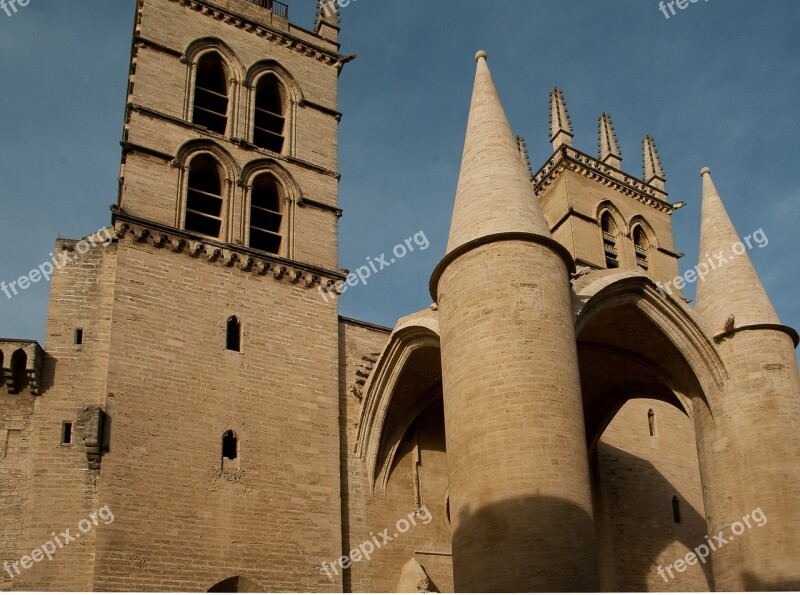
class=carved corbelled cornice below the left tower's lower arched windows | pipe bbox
[111,210,346,291]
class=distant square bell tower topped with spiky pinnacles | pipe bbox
[533,88,682,283]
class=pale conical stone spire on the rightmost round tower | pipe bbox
[696,167,780,333]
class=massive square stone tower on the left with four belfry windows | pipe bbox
[1,0,347,591]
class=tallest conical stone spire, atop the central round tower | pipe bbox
[447,51,550,254]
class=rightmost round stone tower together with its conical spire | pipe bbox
[696,168,800,591]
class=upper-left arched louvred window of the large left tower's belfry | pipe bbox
[192,52,229,134]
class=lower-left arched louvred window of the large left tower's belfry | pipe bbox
[185,153,222,238]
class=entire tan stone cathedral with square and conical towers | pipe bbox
[0,0,800,592]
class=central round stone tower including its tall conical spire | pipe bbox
[431,52,600,592]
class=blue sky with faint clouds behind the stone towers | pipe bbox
[0,0,800,341]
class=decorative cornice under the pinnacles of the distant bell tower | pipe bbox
[533,146,675,215]
